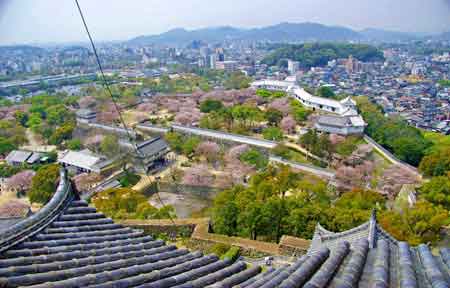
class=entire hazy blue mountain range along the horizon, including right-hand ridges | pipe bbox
[129,22,442,45]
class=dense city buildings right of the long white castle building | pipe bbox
[279,49,450,134]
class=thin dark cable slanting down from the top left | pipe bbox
[75,0,175,225]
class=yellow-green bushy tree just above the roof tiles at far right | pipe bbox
[380,200,450,245]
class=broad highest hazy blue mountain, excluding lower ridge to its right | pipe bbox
[130,23,361,45]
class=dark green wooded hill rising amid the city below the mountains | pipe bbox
[263,43,384,68]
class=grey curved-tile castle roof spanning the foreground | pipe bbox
[0,173,450,288]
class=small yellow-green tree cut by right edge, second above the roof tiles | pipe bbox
[419,176,450,210]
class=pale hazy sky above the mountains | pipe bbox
[0,0,450,45]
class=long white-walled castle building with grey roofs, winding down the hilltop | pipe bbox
[252,78,366,135]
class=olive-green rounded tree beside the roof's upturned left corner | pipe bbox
[28,164,59,204]
